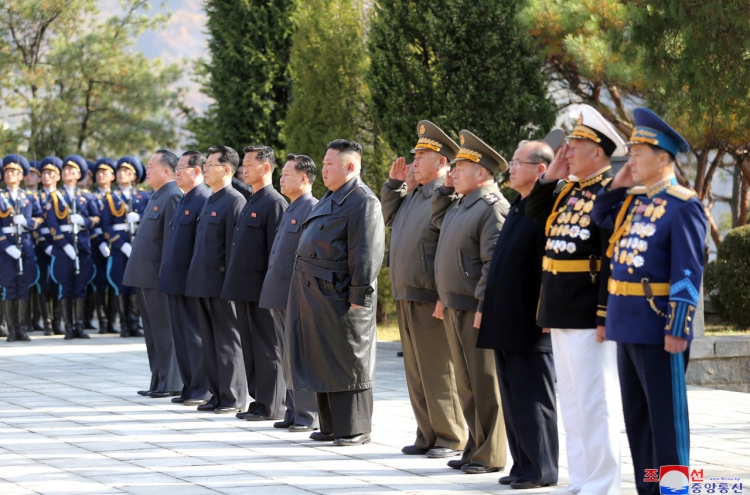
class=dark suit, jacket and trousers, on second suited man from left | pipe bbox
[159,184,211,401]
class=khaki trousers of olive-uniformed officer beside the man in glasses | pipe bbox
[443,308,508,467]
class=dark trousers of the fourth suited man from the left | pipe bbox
[234,301,286,419]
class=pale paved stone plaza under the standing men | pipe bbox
[0,338,750,495]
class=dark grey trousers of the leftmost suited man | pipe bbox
[137,288,182,392]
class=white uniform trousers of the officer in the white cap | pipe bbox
[551,328,622,495]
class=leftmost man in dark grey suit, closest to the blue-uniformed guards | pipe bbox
[122,150,182,398]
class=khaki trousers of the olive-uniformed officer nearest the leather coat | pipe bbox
[396,301,466,450]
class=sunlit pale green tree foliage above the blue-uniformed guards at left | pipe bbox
[0,0,179,157]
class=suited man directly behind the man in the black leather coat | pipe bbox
[260,154,318,431]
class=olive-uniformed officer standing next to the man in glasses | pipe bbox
[431,130,510,474]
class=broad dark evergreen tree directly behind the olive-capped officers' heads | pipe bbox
[369,0,555,160]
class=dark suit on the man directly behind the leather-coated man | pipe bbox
[258,193,318,429]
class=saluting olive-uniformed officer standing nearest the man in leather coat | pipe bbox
[380,120,466,458]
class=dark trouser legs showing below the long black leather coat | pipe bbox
[316,388,373,438]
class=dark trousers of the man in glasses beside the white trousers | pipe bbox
[495,350,559,485]
